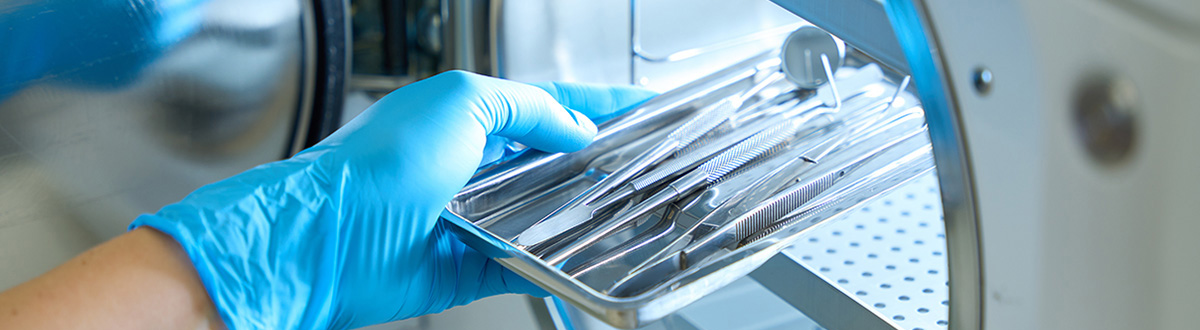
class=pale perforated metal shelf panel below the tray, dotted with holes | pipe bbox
[787,173,949,330]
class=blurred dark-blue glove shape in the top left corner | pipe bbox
[0,0,209,101]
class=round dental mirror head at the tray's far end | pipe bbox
[781,25,846,89]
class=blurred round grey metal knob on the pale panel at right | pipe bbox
[1074,74,1139,166]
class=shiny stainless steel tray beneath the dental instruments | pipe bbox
[443,53,932,328]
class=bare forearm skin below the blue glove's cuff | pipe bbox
[0,228,223,329]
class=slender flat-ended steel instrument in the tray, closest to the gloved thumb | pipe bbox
[516,72,784,246]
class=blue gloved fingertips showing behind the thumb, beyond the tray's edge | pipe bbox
[530,82,659,122]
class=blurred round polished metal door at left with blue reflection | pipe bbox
[0,0,346,272]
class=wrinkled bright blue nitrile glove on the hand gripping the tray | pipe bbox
[130,72,653,329]
